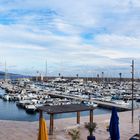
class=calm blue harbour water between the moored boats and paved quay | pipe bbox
[0,89,111,121]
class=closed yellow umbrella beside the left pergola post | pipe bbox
[38,118,49,140]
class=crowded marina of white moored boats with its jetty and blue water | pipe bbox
[0,78,140,121]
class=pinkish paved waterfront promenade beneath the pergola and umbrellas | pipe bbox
[0,110,140,140]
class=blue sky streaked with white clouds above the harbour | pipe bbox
[0,0,140,76]
